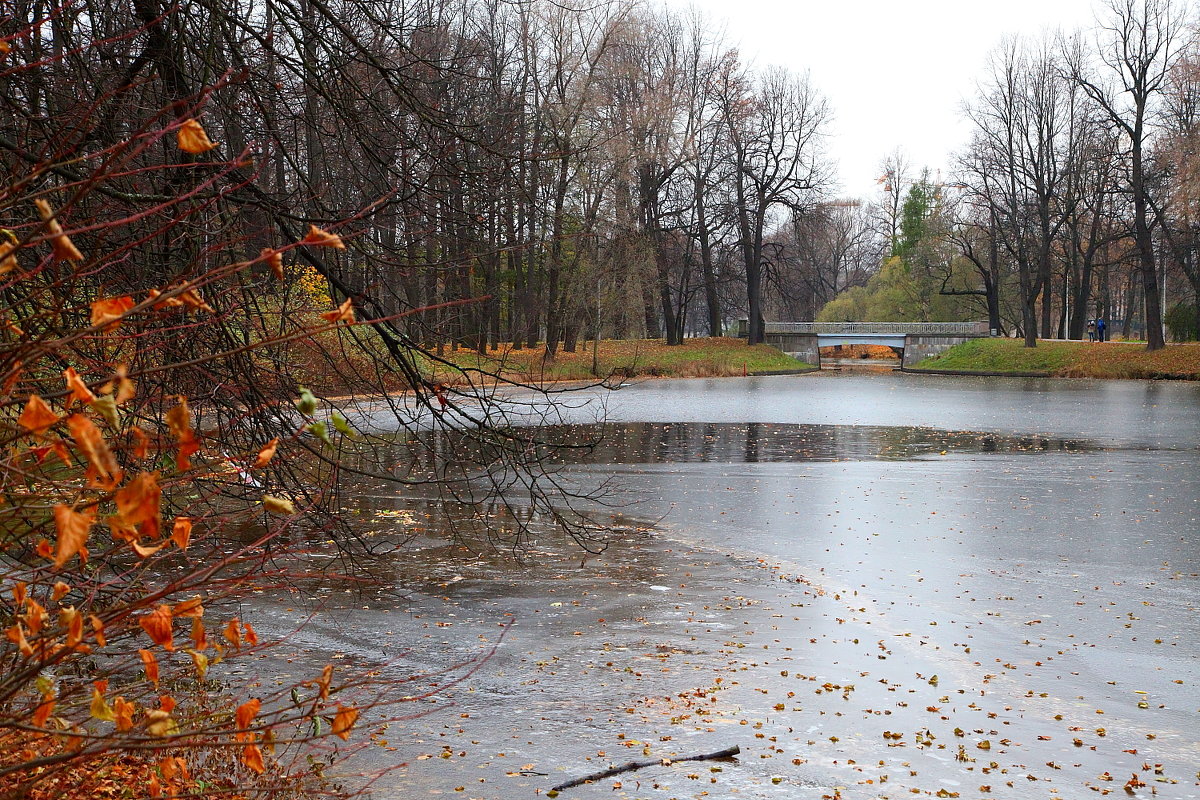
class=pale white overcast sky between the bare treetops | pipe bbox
[666,0,1096,197]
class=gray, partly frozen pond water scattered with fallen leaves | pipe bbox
[248,373,1200,799]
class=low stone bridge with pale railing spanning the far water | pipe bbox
[738,319,991,367]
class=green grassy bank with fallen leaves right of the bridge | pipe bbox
[916,338,1200,380]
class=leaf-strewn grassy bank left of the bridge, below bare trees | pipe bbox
[431,338,811,383]
